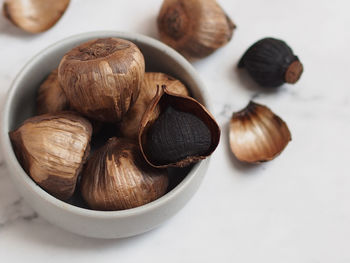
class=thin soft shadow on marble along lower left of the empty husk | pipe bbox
[221,121,262,175]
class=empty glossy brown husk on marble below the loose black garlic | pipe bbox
[229,101,292,163]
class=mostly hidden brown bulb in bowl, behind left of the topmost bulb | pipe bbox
[36,69,69,114]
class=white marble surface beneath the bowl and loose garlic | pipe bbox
[0,0,350,263]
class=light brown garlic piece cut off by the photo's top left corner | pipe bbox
[3,0,70,33]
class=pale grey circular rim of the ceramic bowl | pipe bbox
[0,31,210,218]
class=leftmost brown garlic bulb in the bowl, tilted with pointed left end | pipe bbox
[10,112,92,200]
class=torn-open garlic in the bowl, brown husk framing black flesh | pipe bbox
[138,86,220,168]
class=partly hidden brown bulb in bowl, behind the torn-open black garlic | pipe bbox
[120,72,189,139]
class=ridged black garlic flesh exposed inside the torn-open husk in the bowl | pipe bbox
[146,106,211,164]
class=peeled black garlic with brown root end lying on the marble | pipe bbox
[238,38,303,87]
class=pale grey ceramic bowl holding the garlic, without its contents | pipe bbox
[0,31,209,238]
